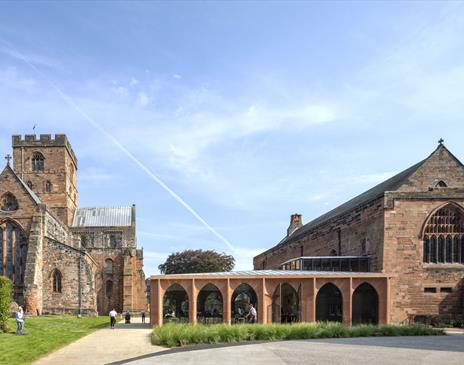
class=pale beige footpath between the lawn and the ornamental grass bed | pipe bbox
[33,318,165,365]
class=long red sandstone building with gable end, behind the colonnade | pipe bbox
[254,141,464,323]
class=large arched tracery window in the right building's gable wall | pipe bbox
[423,203,464,263]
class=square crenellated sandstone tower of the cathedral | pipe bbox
[12,134,78,226]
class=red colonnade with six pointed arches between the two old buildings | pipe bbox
[150,271,390,325]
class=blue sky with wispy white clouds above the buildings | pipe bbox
[0,1,464,275]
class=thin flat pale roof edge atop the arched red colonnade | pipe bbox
[155,270,382,279]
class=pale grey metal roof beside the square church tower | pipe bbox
[72,206,132,227]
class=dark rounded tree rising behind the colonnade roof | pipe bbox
[158,250,235,274]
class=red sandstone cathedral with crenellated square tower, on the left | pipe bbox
[0,134,146,315]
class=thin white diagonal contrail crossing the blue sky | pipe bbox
[0,38,236,252]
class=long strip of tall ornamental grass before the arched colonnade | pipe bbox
[151,322,445,347]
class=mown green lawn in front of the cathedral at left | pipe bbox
[0,316,108,365]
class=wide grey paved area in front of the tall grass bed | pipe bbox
[127,334,464,365]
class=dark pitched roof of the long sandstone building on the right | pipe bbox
[266,144,456,252]
